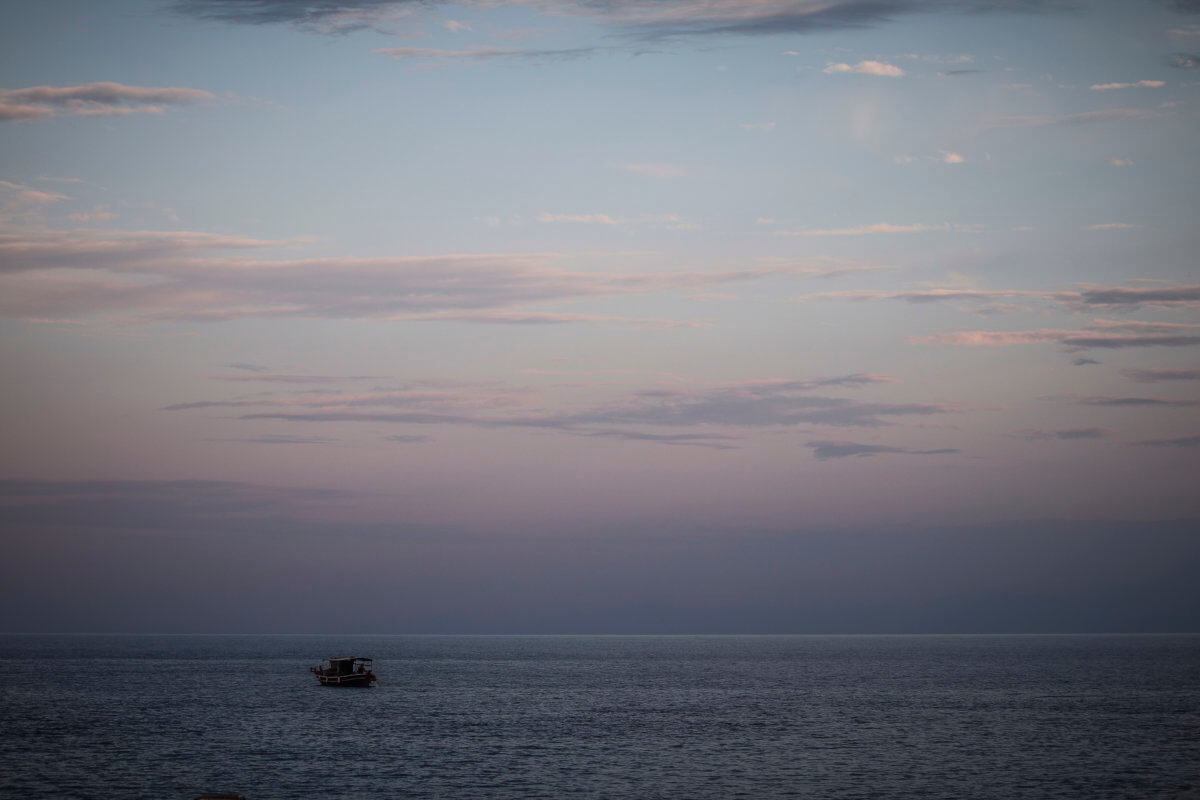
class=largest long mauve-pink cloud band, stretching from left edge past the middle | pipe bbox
[0,226,816,324]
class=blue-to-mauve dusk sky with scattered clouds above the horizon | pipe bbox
[0,0,1200,633]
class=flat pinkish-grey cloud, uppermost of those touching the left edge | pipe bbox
[0,82,215,121]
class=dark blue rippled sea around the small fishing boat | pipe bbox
[0,636,1200,800]
